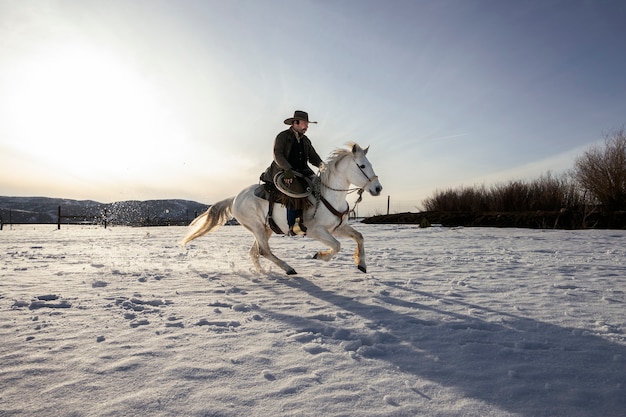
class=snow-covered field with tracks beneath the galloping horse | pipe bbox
[0,224,626,417]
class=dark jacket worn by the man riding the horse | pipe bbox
[261,128,323,182]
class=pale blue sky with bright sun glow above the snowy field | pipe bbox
[0,0,626,214]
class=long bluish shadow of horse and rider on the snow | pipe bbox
[268,278,626,417]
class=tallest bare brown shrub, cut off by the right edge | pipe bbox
[574,127,626,211]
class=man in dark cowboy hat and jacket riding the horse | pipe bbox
[261,110,324,236]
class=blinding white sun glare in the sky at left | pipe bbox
[3,44,183,177]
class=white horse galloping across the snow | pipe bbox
[181,143,383,275]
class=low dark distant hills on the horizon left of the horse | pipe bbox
[0,196,209,226]
